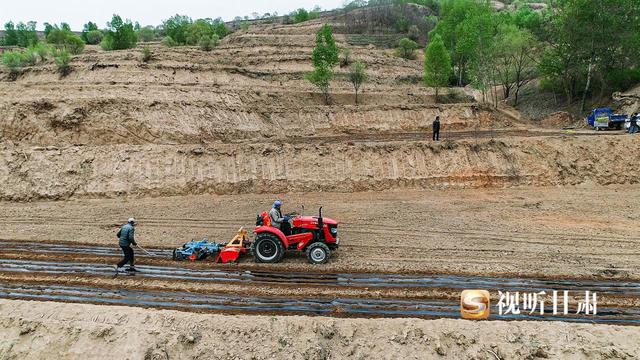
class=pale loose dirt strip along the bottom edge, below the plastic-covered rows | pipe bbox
[0,300,640,359]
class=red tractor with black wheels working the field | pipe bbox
[251,208,340,264]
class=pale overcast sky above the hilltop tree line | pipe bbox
[0,0,344,31]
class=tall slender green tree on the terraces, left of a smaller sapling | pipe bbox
[305,24,340,105]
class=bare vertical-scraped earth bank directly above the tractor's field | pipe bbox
[0,136,640,200]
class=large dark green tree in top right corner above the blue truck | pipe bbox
[539,0,640,110]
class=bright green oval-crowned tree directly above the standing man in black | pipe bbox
[424,35,452,102]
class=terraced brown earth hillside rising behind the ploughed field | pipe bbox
[0,19,639,200]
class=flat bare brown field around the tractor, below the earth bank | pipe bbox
[0,185,640,280]
